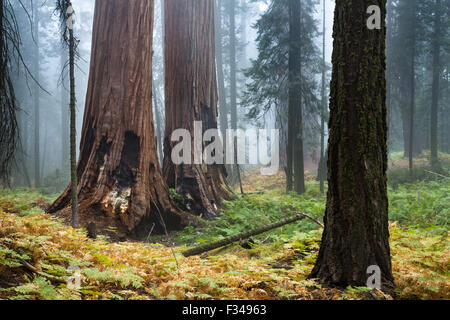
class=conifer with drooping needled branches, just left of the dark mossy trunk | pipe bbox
[243,0,322,193]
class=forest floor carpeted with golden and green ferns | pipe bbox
[0,156,450,300]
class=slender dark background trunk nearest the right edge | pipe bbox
[430,0,441,166]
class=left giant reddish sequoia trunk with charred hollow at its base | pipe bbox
[49,0,193,237]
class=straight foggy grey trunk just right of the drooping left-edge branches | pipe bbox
[33,1,41,188]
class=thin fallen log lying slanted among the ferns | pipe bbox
[183,212,323,257]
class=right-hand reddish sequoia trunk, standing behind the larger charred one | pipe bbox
[164,0,231,218]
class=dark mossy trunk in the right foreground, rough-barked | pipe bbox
[311,0,393,287]
